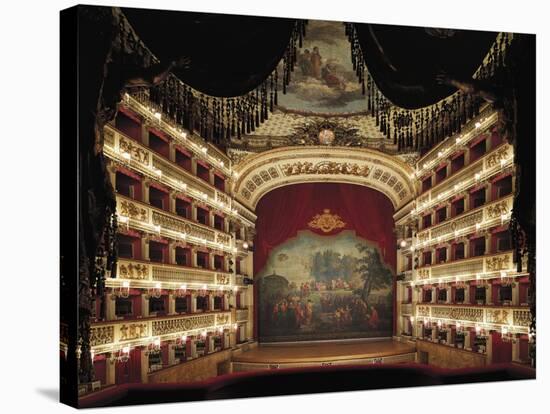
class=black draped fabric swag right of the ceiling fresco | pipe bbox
[354,23,497,109]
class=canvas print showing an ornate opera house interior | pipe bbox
[60,6,536,407]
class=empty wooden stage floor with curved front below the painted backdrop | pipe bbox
[231,339,416,372]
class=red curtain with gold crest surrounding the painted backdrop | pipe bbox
[254,183,397,337]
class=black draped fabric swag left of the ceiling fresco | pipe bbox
[122,8,296,97]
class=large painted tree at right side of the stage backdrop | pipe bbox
[355,243,392,303]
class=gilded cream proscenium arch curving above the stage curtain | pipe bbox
[234,146,415,211]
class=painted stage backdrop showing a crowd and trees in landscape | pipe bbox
[257,230,392,342]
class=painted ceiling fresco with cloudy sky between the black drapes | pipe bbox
[278,20,367,113]
